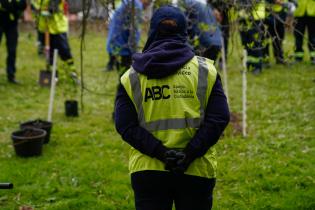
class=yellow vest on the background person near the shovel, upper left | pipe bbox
[32,0,69,34]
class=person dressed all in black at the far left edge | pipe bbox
[0,0,26,84]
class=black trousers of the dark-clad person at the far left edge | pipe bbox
[0,23,18,79]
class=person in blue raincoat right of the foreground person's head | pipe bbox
[184,0,222,61]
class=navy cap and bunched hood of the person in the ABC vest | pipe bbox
[132,6,194,78]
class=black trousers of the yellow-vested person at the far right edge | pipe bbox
[294,16,315,60]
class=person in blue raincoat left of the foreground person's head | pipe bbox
[106,0,150,74]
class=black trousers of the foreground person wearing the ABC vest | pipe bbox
[131,171,215,210]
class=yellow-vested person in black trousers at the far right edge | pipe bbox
[294,0,315,65]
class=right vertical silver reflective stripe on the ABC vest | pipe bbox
[197,56,208,122]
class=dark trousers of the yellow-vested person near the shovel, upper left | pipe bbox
[49,33,73,65]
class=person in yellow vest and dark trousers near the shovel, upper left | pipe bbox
[32,0,75,72]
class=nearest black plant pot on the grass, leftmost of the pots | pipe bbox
[11,128,46,157]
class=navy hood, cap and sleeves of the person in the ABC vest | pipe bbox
[115,6,230,161]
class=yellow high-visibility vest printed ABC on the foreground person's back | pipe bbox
[121,56,217,178]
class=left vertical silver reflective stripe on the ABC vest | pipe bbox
[129,68,145,126]
